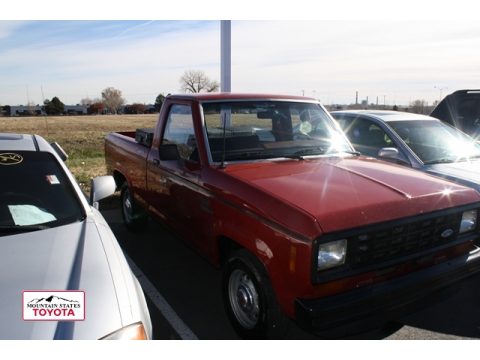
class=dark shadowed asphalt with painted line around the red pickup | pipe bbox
[102,199,480,340]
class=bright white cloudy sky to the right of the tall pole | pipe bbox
[228,21,480,104]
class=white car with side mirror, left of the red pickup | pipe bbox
[0,133,152,339]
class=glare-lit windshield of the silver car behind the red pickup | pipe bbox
[388,121,480,165]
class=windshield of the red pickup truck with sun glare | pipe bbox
[202,100,353,162]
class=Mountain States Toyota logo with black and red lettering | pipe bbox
[23,290,85,321]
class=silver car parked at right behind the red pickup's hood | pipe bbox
[331,110,480,191]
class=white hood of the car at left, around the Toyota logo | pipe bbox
[0,218,121,339]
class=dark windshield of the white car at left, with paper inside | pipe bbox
[0,151,84,236]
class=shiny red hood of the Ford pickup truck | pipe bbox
[227,157,480,236]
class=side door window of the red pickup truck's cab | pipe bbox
[162,105,199,162]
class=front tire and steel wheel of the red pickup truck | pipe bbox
[222,249,289,339]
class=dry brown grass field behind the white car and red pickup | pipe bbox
[0,114,158,191]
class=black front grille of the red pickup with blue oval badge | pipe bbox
[347,212,462,268]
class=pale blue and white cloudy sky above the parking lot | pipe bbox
[0,2,480,105]
